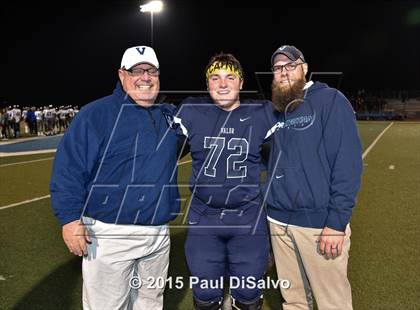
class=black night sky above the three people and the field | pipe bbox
[0,0,420,106]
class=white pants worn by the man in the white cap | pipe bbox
[82,218,170,310]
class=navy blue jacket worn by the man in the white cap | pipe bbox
[50,83,180,225]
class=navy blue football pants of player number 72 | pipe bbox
[185,200,269,302]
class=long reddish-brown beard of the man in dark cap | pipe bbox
[271,78,306,113]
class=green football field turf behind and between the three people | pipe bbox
[0,122,420,310]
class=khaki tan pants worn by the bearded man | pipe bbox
[270,222,353,310]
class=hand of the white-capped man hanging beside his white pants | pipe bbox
[63,220,91,256]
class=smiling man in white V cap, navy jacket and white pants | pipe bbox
[50,46,179,310]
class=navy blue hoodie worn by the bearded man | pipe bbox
[266,82,363,231]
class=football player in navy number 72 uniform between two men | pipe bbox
[174,53,273,310]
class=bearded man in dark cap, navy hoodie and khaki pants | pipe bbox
[267,45,362,310]
